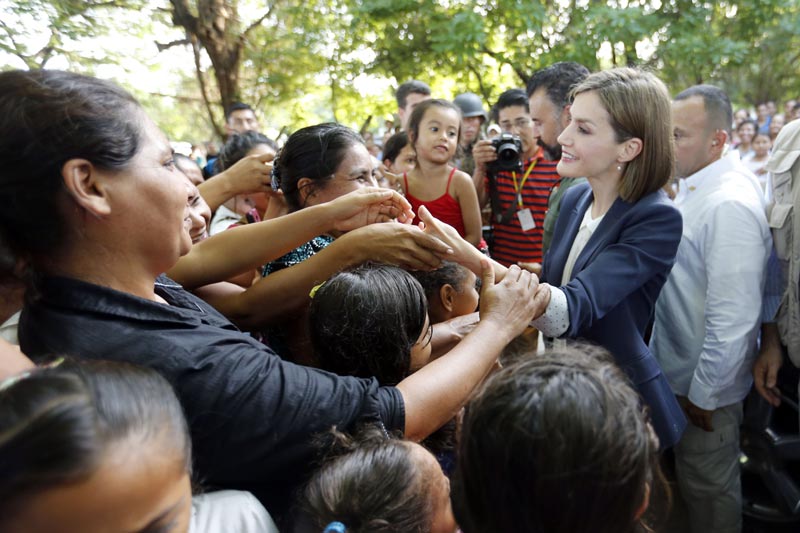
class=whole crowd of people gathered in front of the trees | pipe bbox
[0,62,800,533]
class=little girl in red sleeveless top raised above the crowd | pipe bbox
[403,100,481,247]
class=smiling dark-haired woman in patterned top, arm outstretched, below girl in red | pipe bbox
[258,123,476,363]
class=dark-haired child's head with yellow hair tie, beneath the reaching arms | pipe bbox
[309,264,432,385]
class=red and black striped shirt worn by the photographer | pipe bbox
[486,148,559,266]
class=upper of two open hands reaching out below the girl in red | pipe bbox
[325,187,414,232]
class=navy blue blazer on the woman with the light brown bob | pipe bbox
[541,183,686,448]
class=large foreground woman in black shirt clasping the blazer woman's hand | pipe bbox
[0,70,541,515]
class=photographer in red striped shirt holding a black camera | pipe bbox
[472,89,559,266]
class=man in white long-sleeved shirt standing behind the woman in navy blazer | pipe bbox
[650,85,771,533]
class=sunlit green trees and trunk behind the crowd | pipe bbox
[0,0,800,140]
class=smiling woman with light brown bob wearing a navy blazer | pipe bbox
[421,68,686,448]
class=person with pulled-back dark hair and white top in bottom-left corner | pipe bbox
[0,361,277,533]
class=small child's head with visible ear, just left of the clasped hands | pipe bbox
[411,261,480,324]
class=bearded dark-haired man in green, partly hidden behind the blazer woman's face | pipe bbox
[527,61,589,258]
